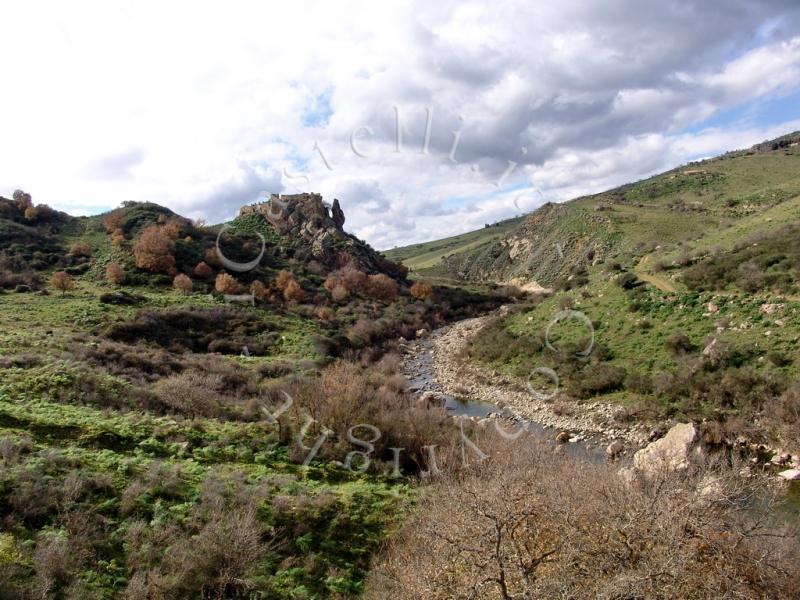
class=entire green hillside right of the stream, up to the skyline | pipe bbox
[406,133,800,448]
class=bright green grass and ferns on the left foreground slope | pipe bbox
[0,278,413,600]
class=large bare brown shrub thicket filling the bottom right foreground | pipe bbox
[366,436,800,600]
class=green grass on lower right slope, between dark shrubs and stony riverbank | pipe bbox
[466,266,800,418]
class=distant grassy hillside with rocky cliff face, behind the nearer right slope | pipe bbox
[389,132,800,286]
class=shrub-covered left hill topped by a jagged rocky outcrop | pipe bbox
[0,192,510,600]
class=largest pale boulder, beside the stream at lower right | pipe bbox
[633,423,707,475]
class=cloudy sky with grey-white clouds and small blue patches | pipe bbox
[0,0,800,249]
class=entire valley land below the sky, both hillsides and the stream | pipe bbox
[0,134,800,600]
